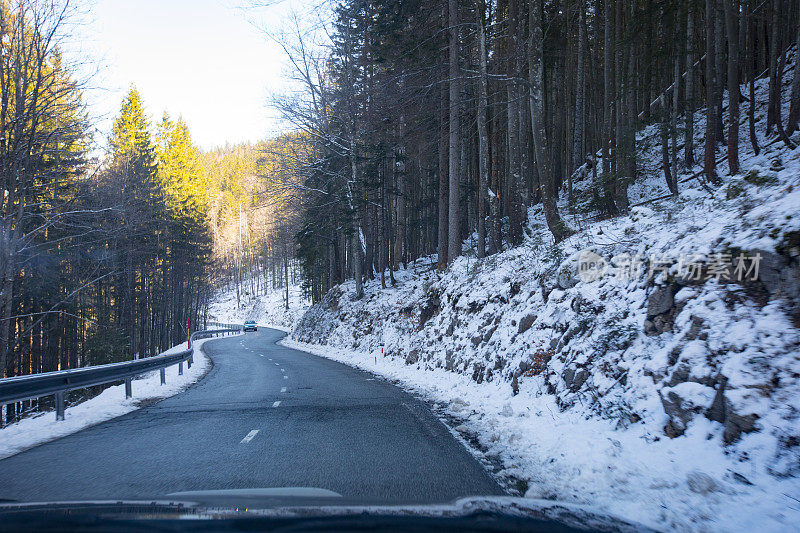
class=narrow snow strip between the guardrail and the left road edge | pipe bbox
[0,339,227,459]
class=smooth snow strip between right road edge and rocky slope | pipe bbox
[280,337,800,532]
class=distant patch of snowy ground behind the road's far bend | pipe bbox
[208,283,311,331]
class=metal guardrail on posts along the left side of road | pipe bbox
[0,324,242,420]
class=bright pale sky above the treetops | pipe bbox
[80,0,283,148]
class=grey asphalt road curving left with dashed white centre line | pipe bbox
[0,329,504,503]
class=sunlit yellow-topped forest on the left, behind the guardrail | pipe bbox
[0,0,289,424]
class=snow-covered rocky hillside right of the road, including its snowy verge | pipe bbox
[288,55,800,531]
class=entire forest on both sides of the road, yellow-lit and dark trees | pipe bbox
[0,0,800,421]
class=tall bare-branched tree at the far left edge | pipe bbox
[0,0,84,377]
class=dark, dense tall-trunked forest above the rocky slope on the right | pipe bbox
[268,0,800,301]
